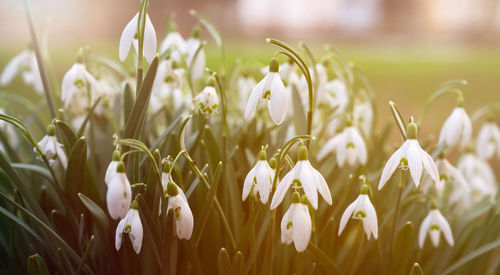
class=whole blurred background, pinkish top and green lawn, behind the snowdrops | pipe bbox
[0,0,500,137]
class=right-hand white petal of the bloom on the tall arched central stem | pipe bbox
[267,73,288,125]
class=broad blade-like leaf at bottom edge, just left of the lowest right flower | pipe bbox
[390,221,413,274]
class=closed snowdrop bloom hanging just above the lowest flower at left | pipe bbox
[106,161,132,220]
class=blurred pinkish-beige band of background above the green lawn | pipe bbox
[0,0,500,45]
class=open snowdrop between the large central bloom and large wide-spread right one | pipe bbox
[338,184,378,240]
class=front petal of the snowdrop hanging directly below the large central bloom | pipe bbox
[292,203,312,252]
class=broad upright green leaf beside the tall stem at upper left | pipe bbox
[123,55,158,138]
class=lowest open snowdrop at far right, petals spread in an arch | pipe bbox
[418,205,453,248]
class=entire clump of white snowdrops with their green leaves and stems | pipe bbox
[0,0,500,274]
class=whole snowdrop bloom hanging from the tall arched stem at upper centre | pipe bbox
[245,58,288,125]
